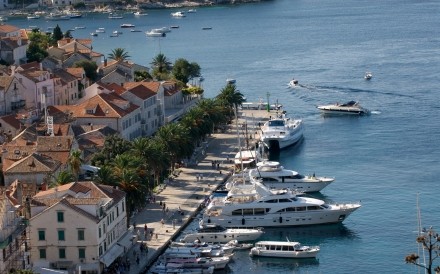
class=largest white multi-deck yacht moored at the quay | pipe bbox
[203,178,361,228]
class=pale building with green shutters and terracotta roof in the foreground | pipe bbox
[29,182,132,274]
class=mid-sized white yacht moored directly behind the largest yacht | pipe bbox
[249,161,335,192]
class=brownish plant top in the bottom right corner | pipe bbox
[405,227,440,274]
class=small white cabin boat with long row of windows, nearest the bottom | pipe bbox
[249,241,319,258]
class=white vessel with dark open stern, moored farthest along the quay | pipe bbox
[261,112,304,150]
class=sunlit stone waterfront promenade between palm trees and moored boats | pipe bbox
[123,110,273,274]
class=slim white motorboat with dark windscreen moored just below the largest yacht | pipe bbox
[181,223,263,243]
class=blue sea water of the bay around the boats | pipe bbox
[8,0,440,273]
